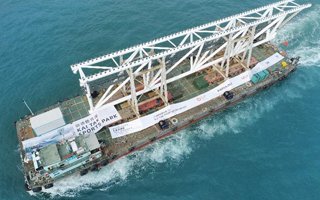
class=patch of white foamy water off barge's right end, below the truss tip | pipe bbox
[275,4,320,67]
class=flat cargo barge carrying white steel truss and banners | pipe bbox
[16,1,311,192]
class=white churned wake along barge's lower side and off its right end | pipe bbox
[36,6,320,197]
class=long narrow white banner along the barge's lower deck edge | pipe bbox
[109,53,284,138]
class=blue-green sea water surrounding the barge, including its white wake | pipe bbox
[0,0,320,200]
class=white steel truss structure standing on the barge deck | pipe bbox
[71,0,311,113]
